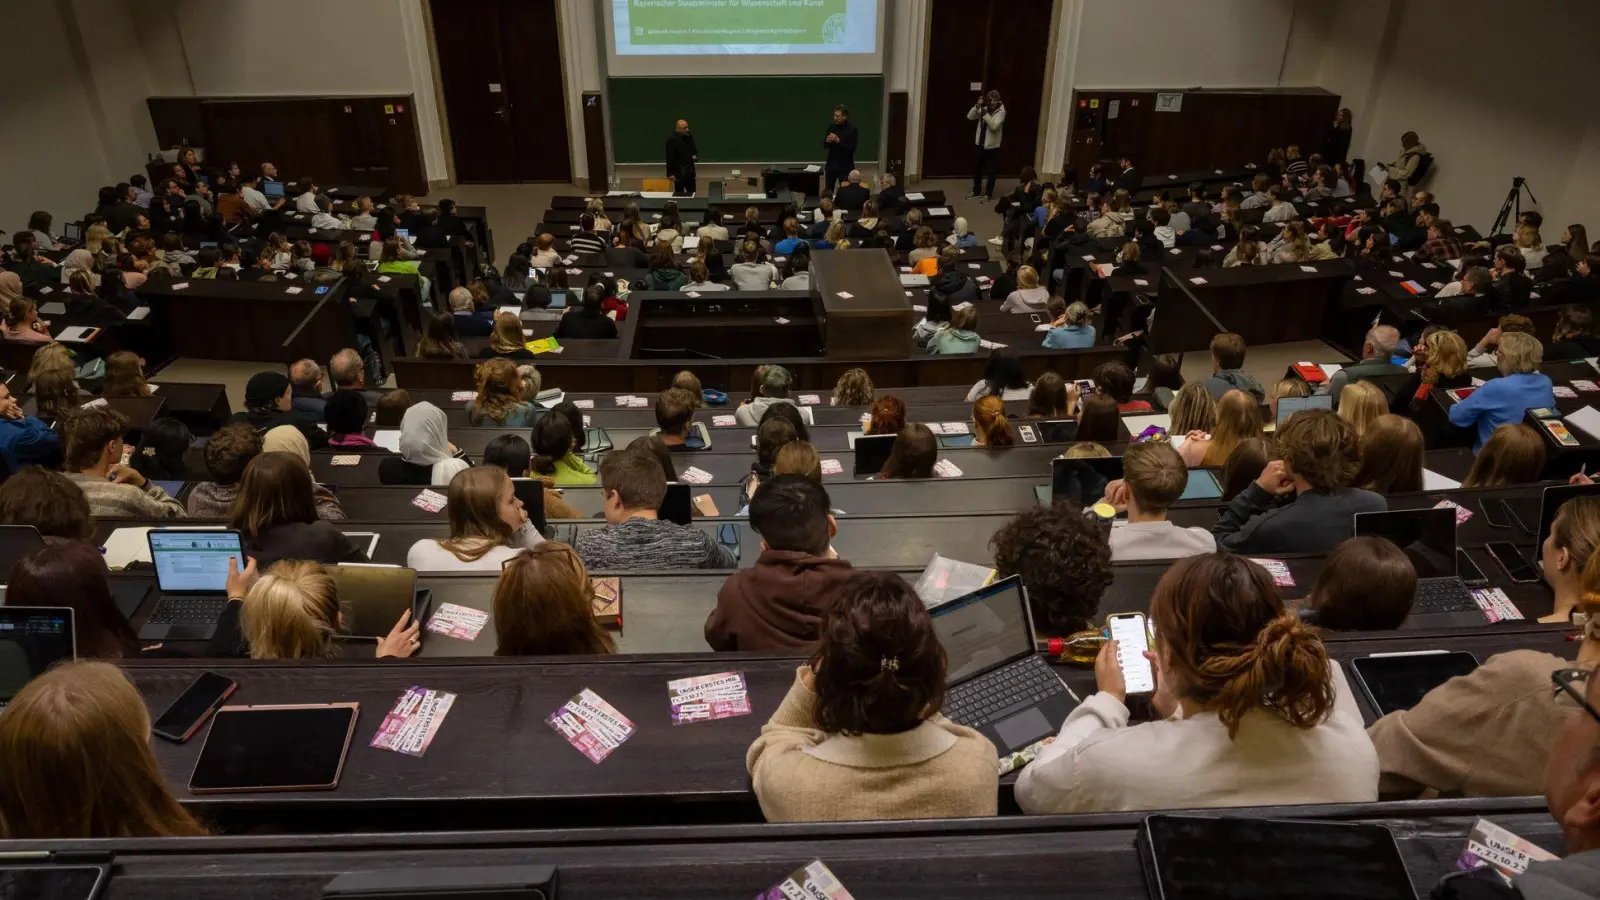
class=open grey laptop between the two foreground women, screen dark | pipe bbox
[930,575,1078,753]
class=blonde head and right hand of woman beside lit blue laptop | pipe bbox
[228,559,422,660]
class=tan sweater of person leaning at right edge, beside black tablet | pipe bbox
[1366,650,1579,798]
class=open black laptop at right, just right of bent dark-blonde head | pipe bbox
[1355,506,1488,628]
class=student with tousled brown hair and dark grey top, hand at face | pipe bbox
[1216,410,1389,552]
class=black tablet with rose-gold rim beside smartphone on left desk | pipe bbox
[189,703,360,794]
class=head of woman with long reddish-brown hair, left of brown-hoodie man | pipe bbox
[491,541,616,657]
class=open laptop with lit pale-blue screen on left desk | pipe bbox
[139,528,245,641]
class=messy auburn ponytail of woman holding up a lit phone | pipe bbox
[1195,615,1334,738]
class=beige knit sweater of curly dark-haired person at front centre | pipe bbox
[746,666,1000,822]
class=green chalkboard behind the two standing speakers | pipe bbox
[606,75,883,163]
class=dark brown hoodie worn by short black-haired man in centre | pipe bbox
[706,549,856,650]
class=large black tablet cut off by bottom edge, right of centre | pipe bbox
[1138,815,1416,900]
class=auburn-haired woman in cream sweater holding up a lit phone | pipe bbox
[1016,552,1378,814]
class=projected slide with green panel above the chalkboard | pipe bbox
[608,0,882,75]
